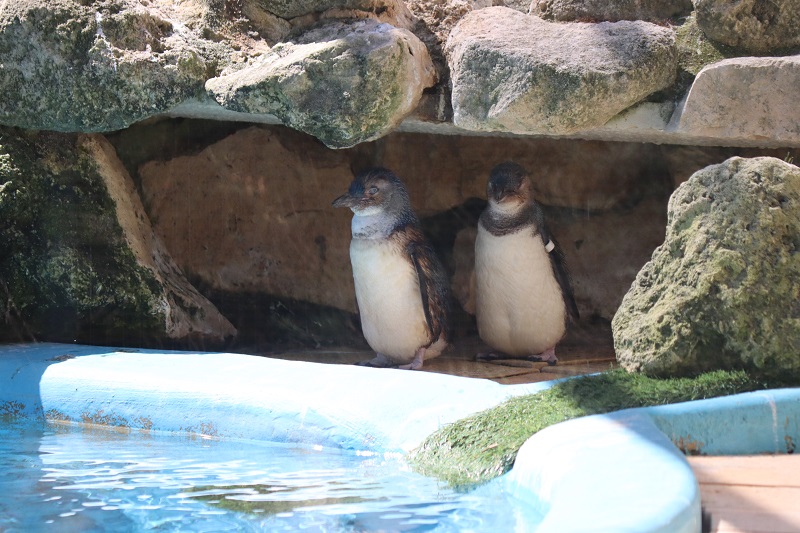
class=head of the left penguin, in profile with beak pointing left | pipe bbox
[332,167,411,216]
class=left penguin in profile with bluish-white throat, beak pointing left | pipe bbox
[333,168,450,370]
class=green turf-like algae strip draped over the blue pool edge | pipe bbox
[408,370,784,488]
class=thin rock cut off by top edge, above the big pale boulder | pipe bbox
[530,0,692,23]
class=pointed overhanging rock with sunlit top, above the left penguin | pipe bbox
[206,20,435,148]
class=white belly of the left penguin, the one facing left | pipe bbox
[350,239,434,364]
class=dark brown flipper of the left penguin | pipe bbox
[408,239,450,344]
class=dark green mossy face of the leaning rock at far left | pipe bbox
[0,129,166,343]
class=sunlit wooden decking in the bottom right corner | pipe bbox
[689,455,800,533]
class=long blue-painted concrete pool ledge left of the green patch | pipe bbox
[0,344,547,453]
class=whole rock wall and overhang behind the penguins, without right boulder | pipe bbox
[0,0,800,354]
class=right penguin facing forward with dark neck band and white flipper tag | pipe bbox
[475,162,578,365]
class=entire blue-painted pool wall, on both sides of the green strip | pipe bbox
[0,344,800,533]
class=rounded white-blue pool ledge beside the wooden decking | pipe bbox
[507,410,700,533]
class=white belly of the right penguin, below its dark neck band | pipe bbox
[475,226,566,356]
